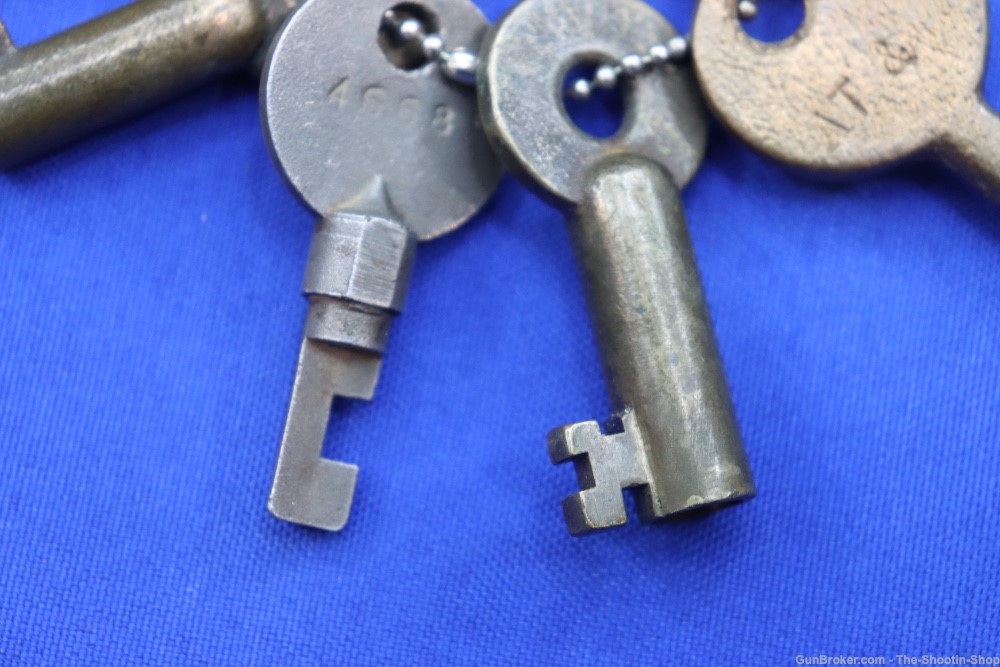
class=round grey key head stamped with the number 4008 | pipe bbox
[261,0,502,240]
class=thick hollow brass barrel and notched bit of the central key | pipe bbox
[549,155,755,534]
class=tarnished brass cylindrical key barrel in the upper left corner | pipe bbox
[0,0,298,167]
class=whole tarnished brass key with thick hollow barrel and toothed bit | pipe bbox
[478,0,755,534]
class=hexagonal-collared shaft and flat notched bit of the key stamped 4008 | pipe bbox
[269,179,416,531]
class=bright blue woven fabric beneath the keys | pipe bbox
[0,0,1000,666]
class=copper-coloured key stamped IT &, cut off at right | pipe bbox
[693,0,1000,198]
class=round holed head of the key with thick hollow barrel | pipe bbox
[478,0,707,206]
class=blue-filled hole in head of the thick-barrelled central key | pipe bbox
[562,61,628,139]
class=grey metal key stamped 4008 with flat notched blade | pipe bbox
[261,0,502,531]
